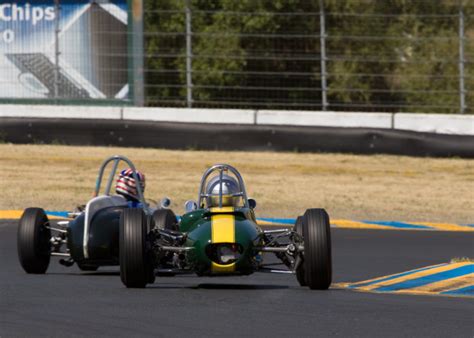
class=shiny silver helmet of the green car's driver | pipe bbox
[206,174,241,208]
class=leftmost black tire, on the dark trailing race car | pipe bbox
[17,208,51,274]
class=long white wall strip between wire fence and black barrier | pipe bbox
[0,105,474,136]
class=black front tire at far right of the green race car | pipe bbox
[303,209,332,290]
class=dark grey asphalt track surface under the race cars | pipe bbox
[0,221,474,338]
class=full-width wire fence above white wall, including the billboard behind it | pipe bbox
[0,0,474,114]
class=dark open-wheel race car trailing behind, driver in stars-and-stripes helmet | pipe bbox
[17,155,177,274]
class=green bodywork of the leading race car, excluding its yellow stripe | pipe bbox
[179,208,262,276]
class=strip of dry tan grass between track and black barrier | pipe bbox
[0,144,474,223]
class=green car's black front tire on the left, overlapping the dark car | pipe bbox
[119,208,153,288]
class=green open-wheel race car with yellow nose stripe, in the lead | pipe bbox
[120,164,332,290]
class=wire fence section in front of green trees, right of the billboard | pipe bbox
[144,0,474,114]
